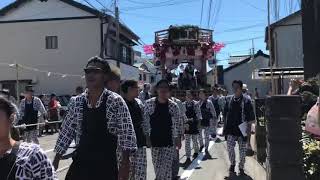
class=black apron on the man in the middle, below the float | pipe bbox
[150,99,173,147]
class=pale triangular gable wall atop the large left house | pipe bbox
[0,0,93,21]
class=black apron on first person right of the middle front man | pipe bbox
[185,102,199,134]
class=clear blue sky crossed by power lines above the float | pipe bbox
[0,0,299,64]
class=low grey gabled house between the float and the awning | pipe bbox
[223,50,270,96]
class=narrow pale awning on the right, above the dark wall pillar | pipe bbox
[252,67,304,80]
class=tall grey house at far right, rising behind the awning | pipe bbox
[265,11,304,94]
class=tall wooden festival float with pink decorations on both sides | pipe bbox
[144,25,224,89]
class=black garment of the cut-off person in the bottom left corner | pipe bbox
[0,143,20,180]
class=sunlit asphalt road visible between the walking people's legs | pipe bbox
[40,131,266,180]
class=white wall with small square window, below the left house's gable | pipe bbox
[0,17,100,94]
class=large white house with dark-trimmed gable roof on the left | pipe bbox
[0,0,139,97]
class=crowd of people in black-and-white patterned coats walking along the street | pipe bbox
[0,57,255,180]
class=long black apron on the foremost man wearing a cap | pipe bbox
[66,96,118,180]
